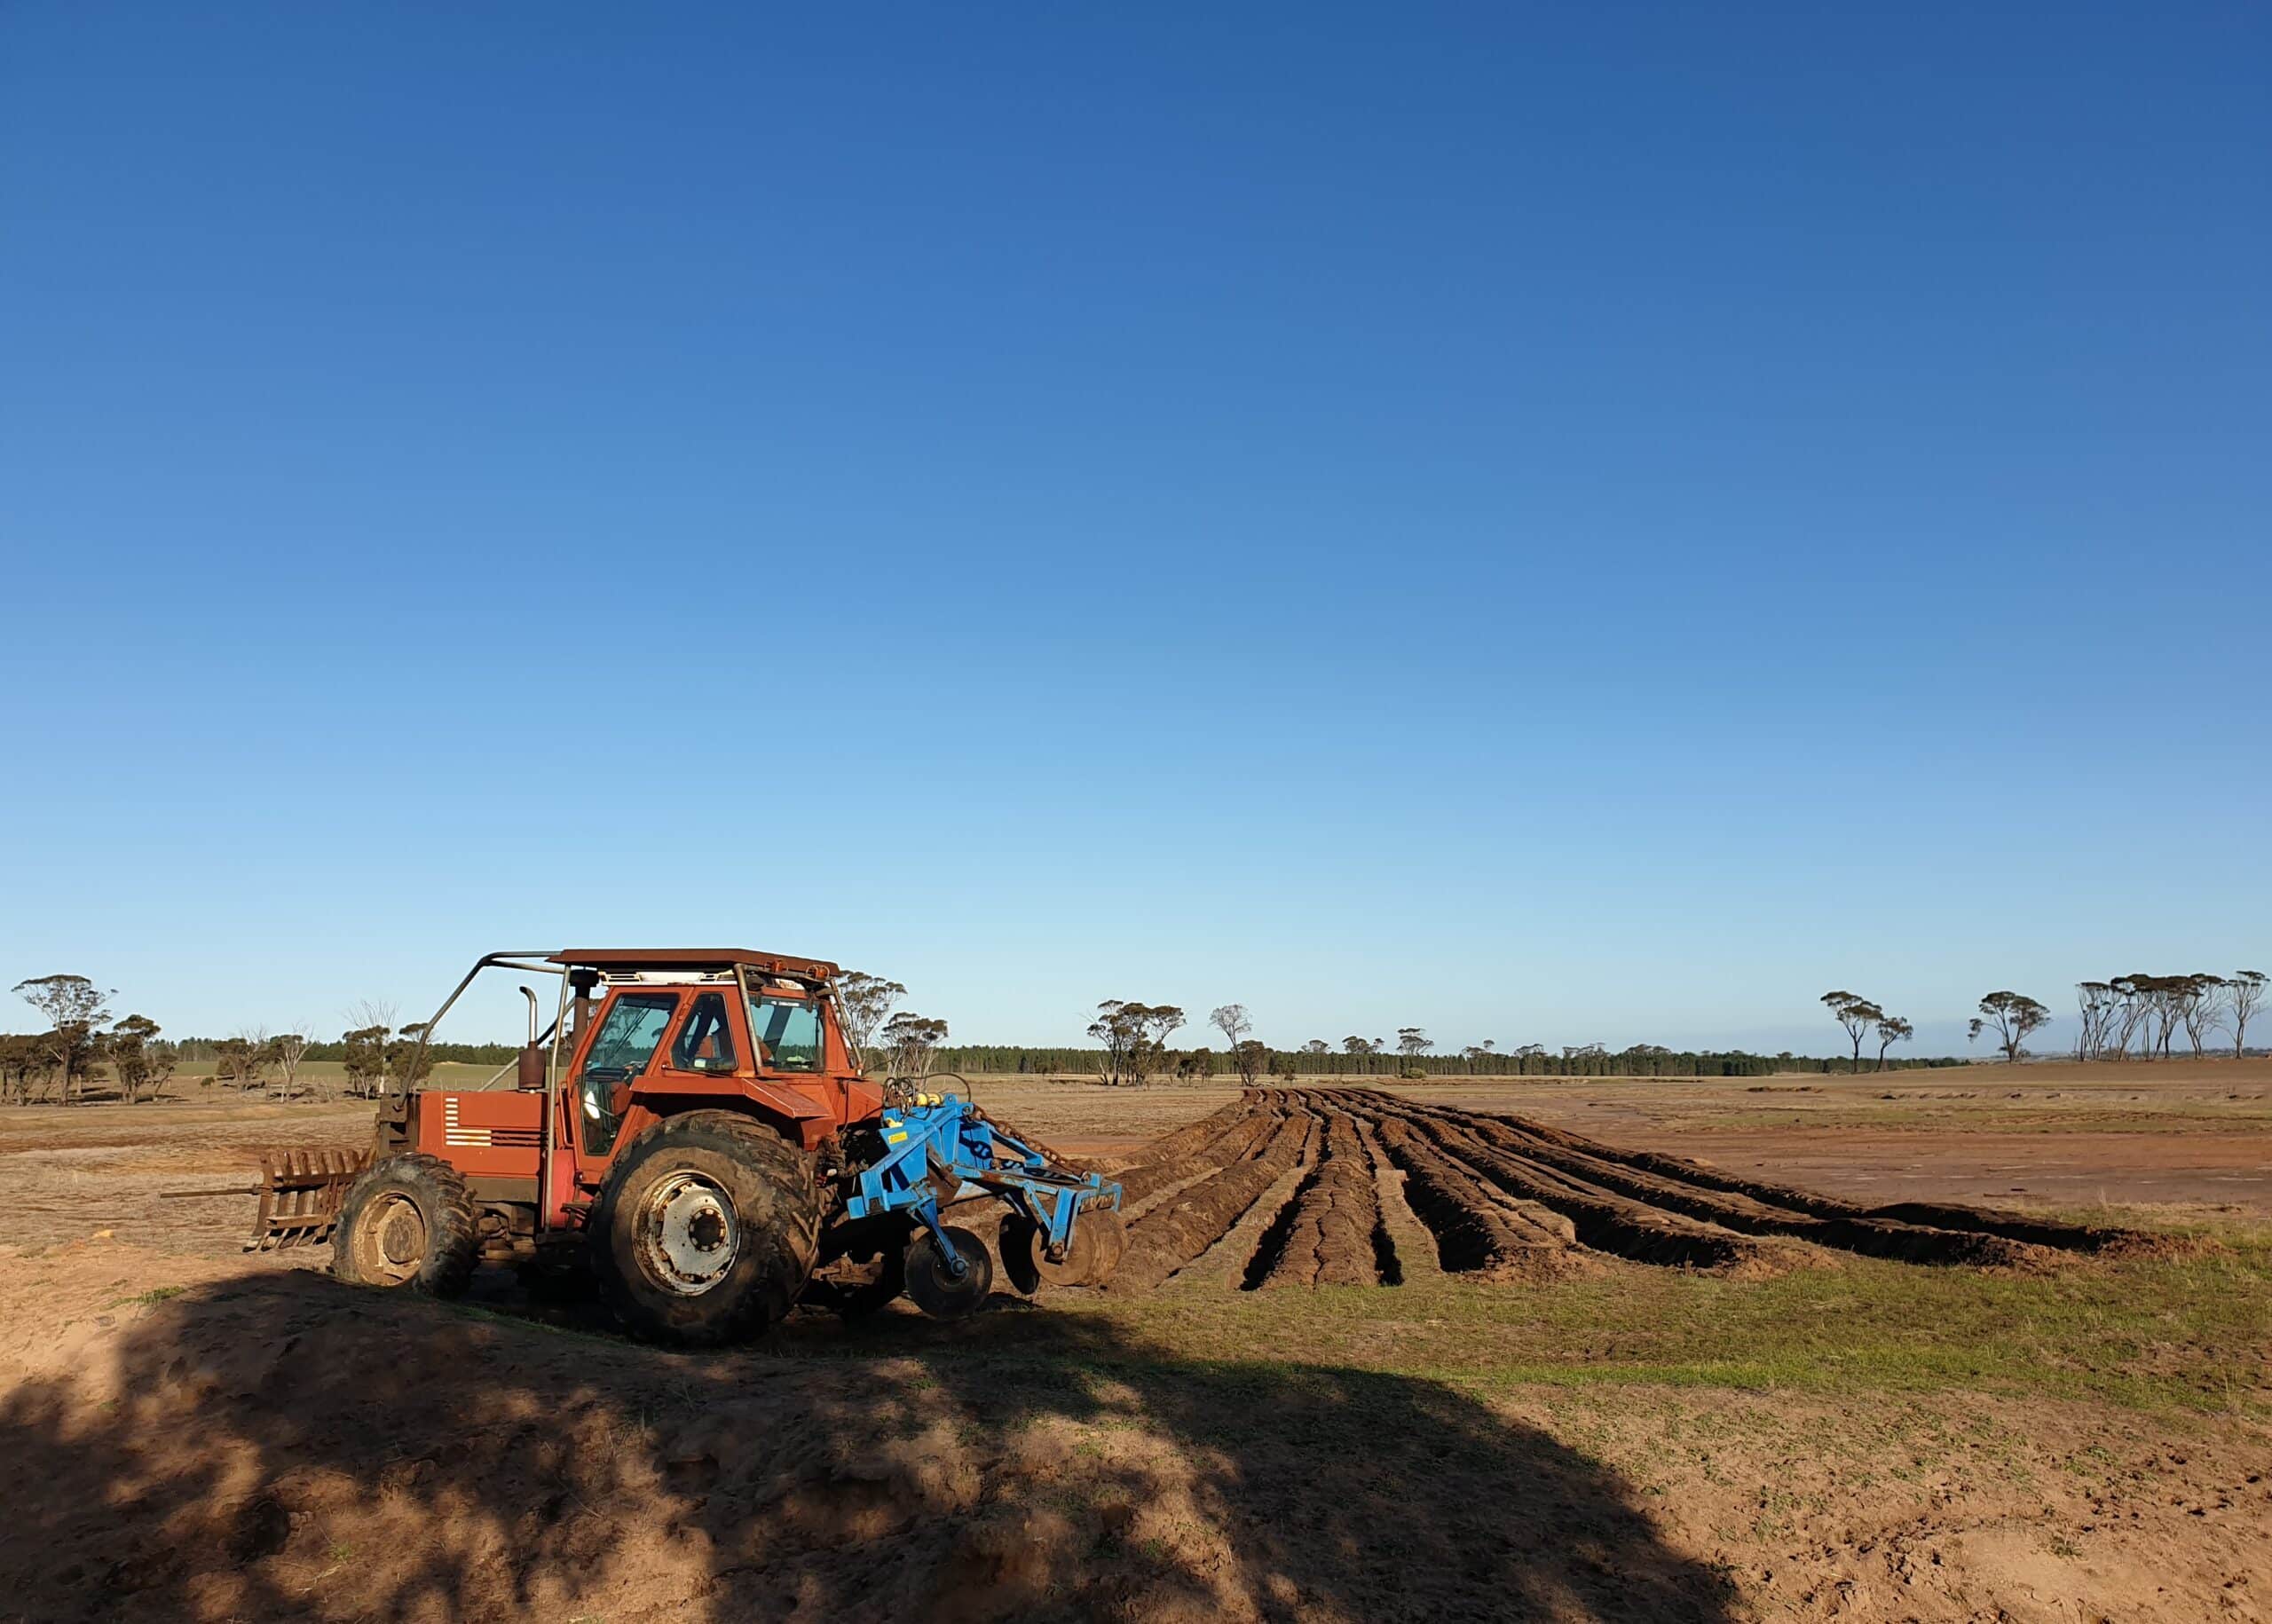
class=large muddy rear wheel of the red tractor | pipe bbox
[591,1111,820,1347]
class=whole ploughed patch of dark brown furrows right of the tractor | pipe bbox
[1081,1088,2163,1292]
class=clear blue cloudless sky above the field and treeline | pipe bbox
[0,4,2272,1049]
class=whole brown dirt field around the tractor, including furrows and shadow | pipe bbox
[0,1060,2272,1624]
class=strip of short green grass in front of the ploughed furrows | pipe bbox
[909,1238,2272,1415]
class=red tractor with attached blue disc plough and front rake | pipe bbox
[288,947,1120,1344]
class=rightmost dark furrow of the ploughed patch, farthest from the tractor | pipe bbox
[1459,1111,2161,1263]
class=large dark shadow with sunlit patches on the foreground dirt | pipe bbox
[0,1272,1733,1621]
